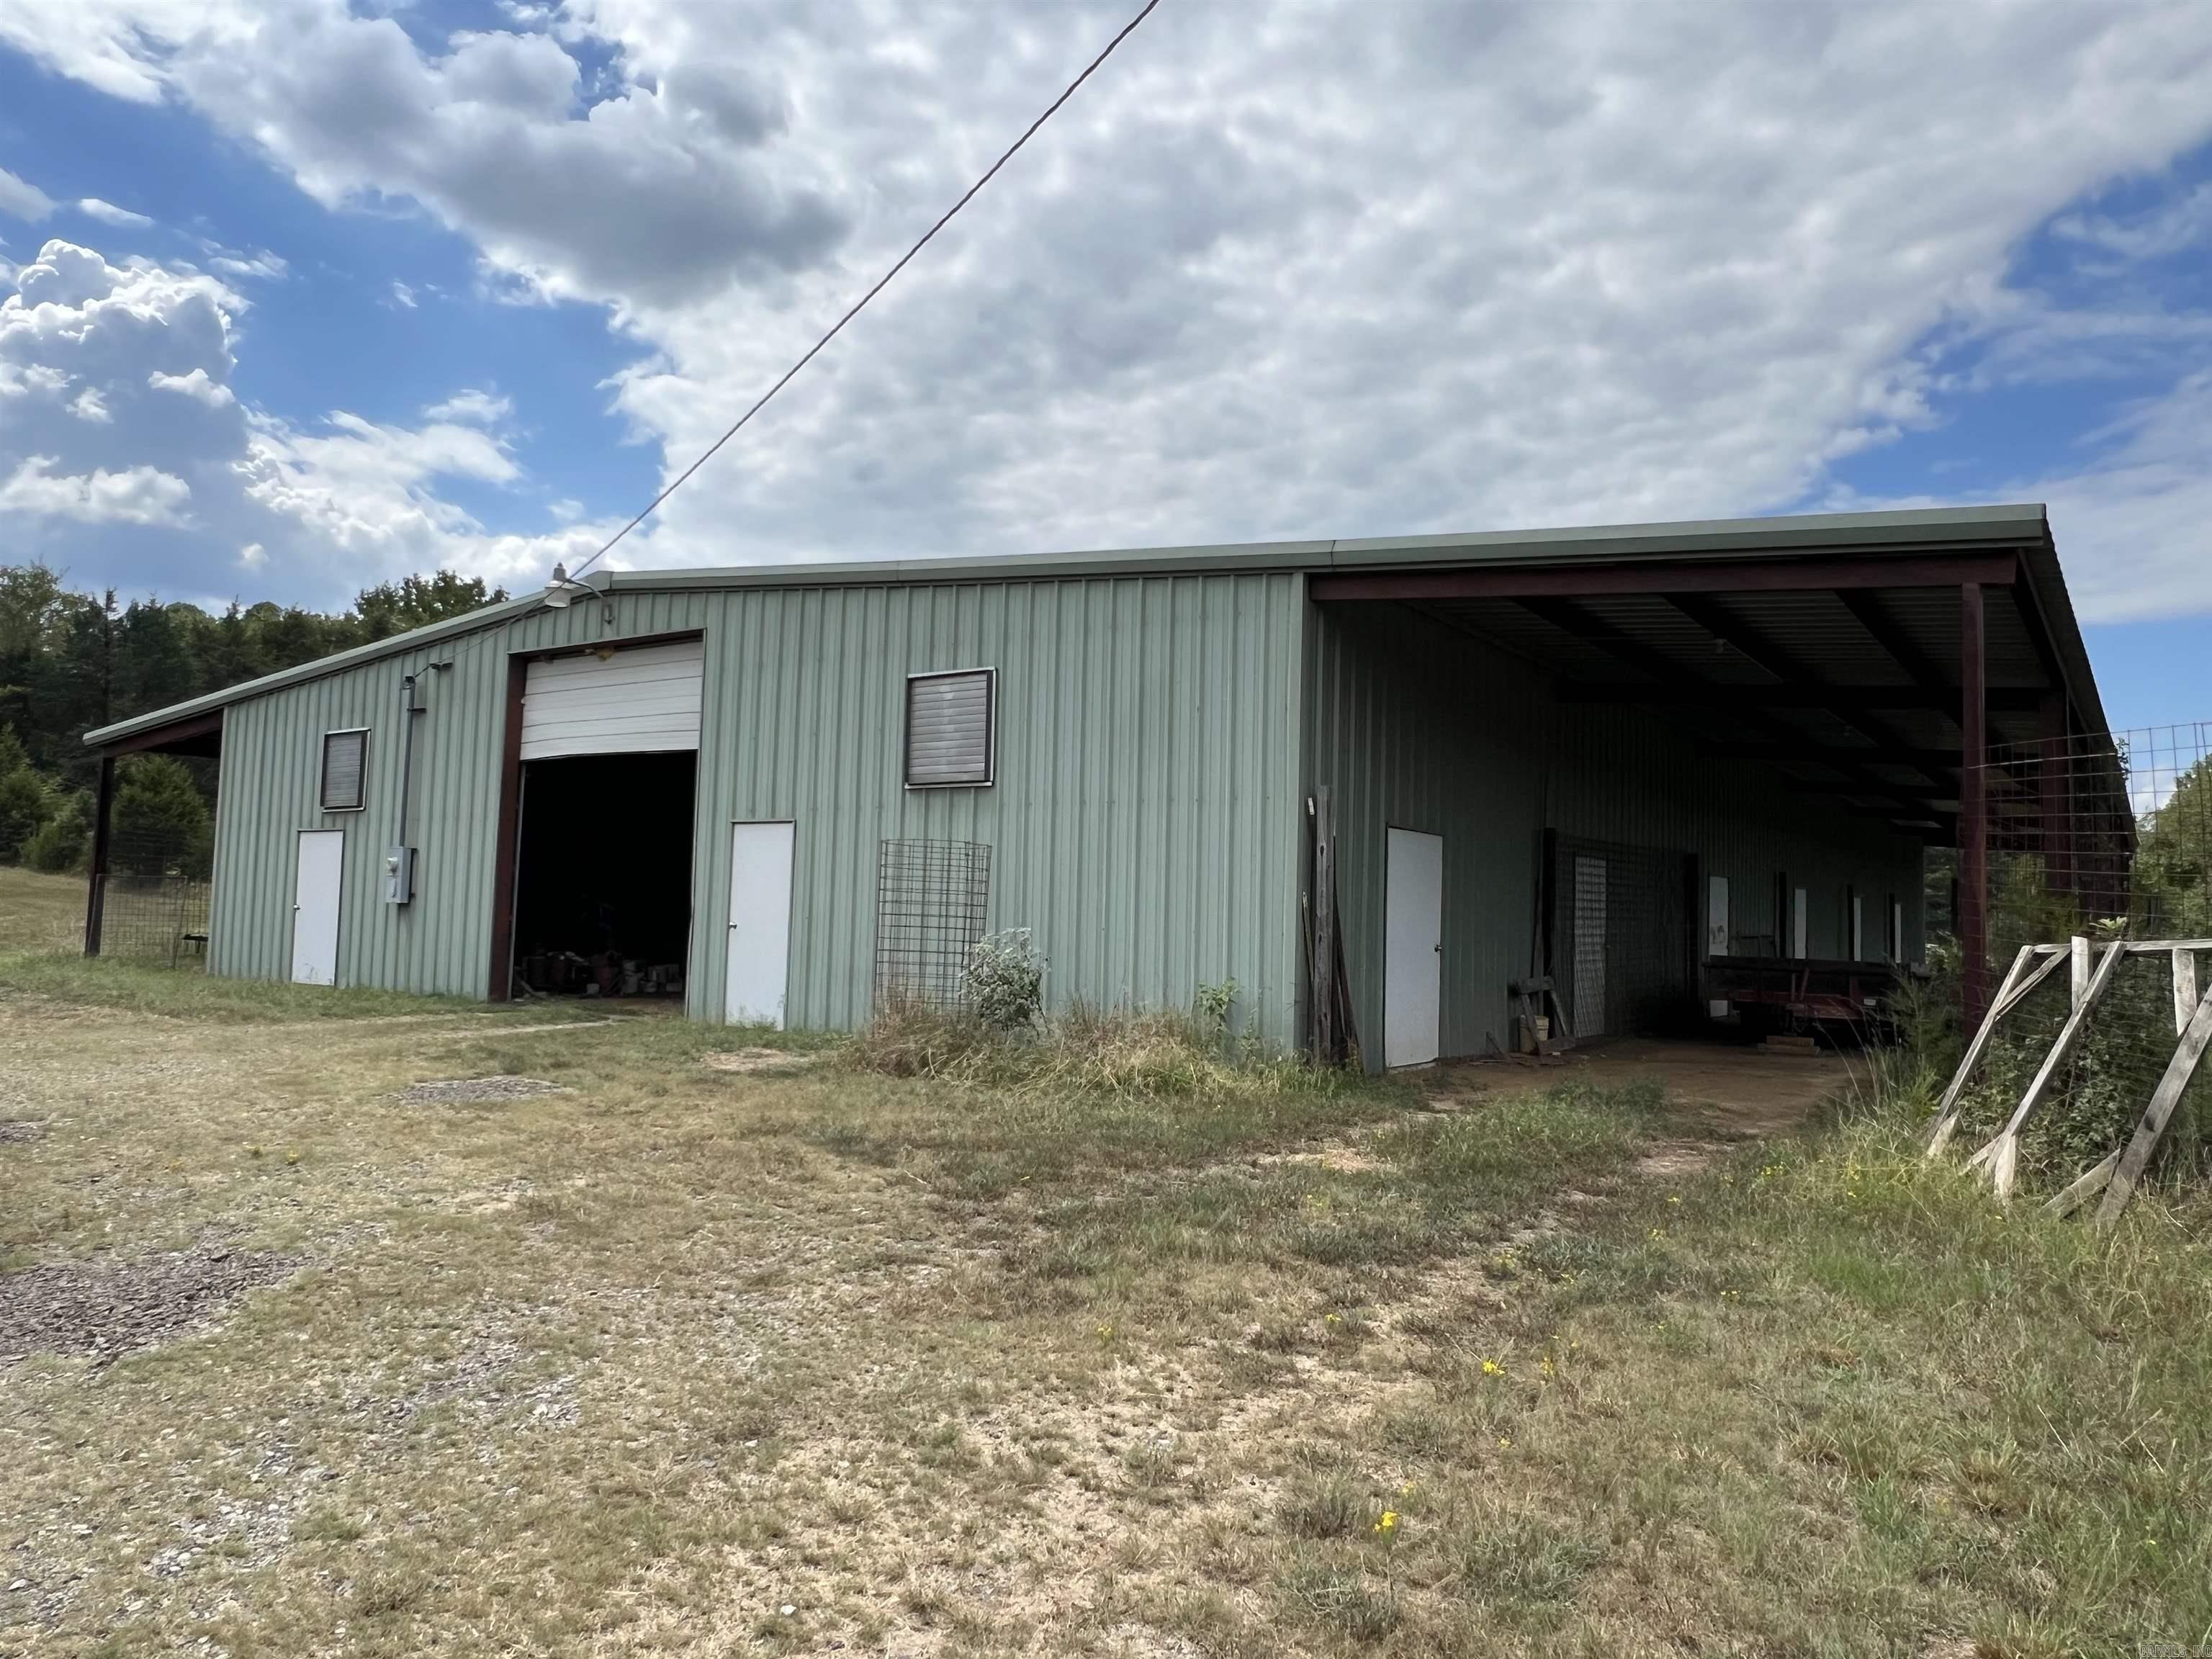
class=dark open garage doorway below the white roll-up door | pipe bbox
[513,750,699,1002]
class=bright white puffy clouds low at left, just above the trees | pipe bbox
[0,241,597,600]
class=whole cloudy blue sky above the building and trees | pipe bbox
[0,0,2212,726]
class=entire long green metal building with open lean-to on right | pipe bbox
[73,506,2103,1064]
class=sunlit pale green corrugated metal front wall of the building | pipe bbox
[210,575,1303,1044]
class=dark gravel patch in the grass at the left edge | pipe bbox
[0,1246,301,1364]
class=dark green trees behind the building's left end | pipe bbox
[0,564,506,876]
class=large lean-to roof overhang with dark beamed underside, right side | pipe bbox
[1310,509,2103,840]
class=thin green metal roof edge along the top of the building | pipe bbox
[84,504,2103,747]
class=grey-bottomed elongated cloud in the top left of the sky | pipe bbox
[0,0,848,301]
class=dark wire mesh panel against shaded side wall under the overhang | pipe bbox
[1550,836,1696,1042]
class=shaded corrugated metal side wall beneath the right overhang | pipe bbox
[1305,604,1923,1057]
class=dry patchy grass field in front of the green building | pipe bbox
[0,915,2212,1657]
